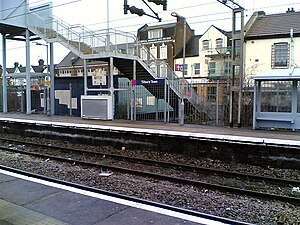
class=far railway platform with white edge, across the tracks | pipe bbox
[0,113,300,147]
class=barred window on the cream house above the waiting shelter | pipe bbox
[272,42,290,68]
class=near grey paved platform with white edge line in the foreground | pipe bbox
[0,169,224,225]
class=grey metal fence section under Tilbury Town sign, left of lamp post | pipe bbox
[115,78,178,122]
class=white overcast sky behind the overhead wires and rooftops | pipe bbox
[0,0,300,67]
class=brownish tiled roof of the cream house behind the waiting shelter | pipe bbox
[245,11,300,39]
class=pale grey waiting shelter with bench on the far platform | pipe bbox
[253,67,300,130]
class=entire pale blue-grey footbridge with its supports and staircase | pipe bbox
[0,0,201,123]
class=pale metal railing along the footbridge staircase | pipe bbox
[27,12,200,110]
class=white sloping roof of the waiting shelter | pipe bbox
[253,67,300,81]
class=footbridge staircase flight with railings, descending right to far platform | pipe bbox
[27,12,201,121]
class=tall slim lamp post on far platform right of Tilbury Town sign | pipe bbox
[171,12,186,126]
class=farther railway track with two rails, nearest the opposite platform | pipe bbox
[0,139,300,205]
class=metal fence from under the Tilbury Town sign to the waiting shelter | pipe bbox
[115,78,253,127]
